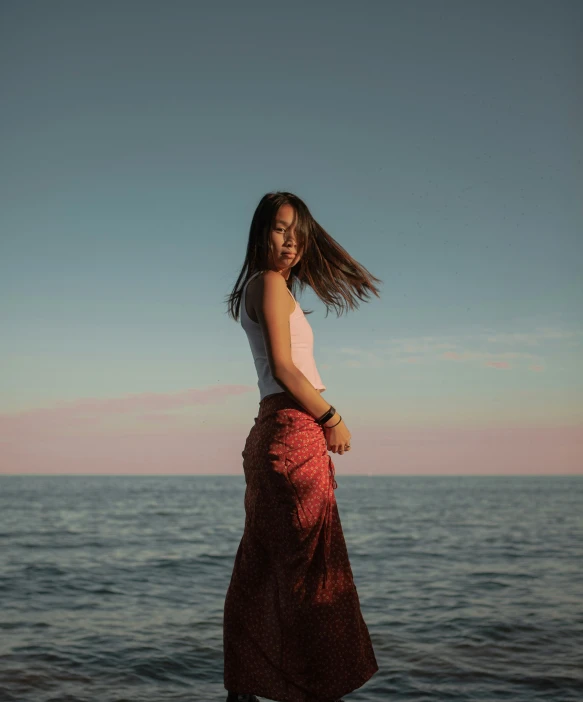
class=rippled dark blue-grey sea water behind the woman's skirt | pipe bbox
[0,470,583,702]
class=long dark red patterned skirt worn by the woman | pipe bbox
[223,392,379,702]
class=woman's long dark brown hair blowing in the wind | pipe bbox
[226,191,383,322]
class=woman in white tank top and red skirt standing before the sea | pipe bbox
[223,192,382,702]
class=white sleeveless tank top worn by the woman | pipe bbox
[241,271,326,402]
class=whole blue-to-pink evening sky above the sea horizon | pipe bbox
[0,0,583,479]
